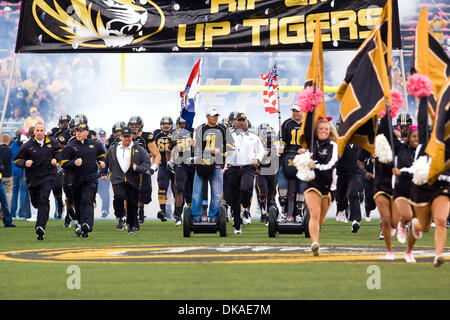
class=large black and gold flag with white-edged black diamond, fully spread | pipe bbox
[338,29,391,156]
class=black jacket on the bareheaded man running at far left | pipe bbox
[14,136,61,187]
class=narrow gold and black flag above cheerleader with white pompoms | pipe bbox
[300,19,327,149]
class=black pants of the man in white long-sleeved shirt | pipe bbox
[227,166,256,229]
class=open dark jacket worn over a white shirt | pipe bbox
[102,143,150,189]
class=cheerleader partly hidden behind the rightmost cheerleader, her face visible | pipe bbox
[392,126,419,263]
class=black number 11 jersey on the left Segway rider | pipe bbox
[194,124,234,167]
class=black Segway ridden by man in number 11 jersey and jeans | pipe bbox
[183,179,227,238]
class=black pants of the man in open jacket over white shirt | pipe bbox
[113,182,139,226]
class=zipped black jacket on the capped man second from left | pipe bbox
[61,139,105,187]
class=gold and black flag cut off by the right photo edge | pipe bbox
[425,81,450,182]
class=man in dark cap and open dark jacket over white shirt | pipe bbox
[102,127,150,233]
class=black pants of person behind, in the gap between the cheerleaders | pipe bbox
[336,173,361,221]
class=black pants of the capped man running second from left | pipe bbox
[73,180,98,231]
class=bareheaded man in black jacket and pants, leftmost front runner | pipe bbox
[14,122,61,240]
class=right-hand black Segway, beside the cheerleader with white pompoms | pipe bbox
[268,162,310,238]
